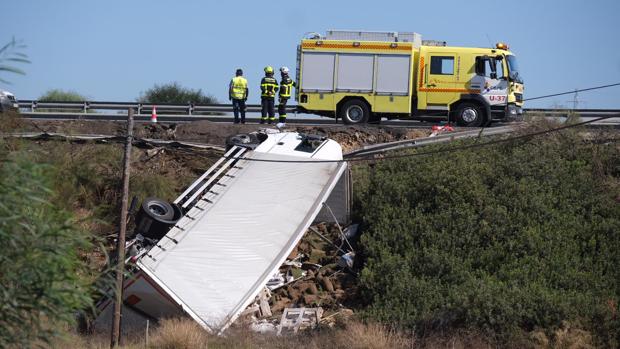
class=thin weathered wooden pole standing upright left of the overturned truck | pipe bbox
[110,108,133,348]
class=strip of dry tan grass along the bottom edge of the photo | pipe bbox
[50,319,594,349]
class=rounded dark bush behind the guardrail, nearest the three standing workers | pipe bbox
[138,82,217,104]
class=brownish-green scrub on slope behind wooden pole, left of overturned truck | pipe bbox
[28,142,199,236]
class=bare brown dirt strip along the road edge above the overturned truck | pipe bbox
[20,120,430,152]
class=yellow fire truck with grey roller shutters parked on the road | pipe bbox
[296,30,524,127]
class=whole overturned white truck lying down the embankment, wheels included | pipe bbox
[95,130,351,334]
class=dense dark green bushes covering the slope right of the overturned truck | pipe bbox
[356,123,620,346]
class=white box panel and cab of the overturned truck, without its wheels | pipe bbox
[138,133,347,333]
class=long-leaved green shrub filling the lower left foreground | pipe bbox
[0,148,92,348]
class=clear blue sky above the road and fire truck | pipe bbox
[0,0,620,108]
